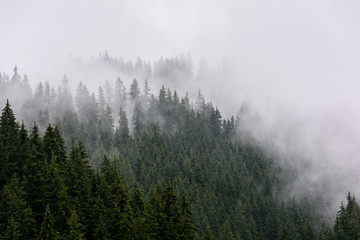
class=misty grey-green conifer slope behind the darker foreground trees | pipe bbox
[2,63,358,239]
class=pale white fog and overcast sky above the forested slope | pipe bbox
[0,0,360,221]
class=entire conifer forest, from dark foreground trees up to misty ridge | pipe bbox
[0,54,360,239]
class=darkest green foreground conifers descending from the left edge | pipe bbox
[0,100,195,239]
